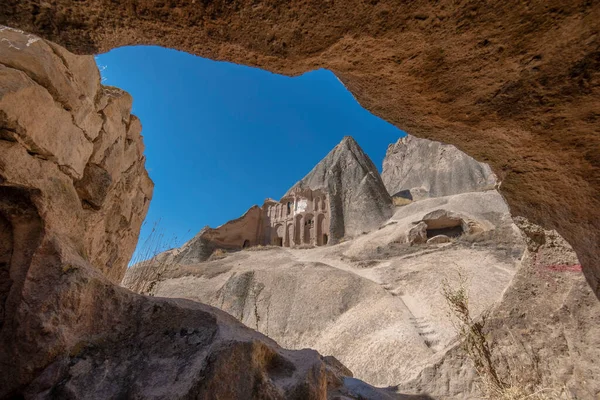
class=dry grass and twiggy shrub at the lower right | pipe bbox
[442,270,570,400]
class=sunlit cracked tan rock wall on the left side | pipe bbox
[0,28,153,282]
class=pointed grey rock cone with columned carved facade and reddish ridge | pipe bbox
[141,136,393,270]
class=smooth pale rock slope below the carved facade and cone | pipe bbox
[124,191,525,387]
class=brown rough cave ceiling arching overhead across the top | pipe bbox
[0,0,600,294]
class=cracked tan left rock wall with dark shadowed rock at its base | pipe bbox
[0,28,387,399]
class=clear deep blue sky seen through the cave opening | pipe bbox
[96,46,404,253]
